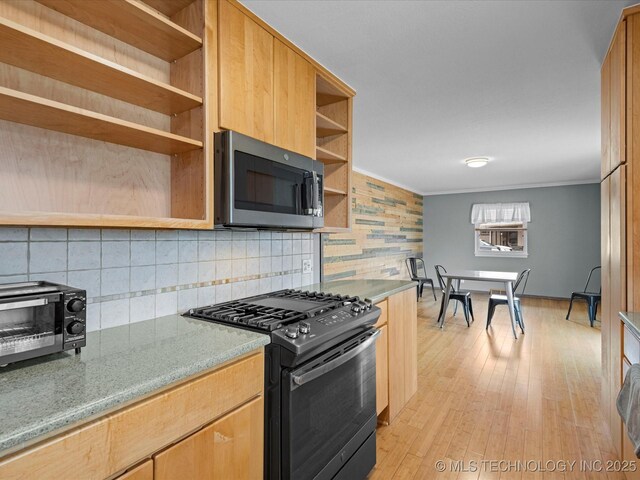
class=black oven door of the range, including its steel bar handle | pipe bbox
[282,329,380,479]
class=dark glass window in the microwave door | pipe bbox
[233,151,306,215]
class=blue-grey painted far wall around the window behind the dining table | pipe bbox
[424,184,600,297]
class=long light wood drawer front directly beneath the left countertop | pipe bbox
[0,352,264,480]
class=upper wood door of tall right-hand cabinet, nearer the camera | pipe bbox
[609,22,627,172]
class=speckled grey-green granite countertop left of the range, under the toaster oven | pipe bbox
[0,315,270,457]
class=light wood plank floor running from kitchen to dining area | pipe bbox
[370,292,624,479]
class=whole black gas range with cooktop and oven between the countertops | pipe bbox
[185,290,380,480]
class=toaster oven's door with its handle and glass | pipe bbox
[0,293,64,364]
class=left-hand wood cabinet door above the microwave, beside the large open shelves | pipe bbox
[218,0,274,143]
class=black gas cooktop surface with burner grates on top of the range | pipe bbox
[186,290,371,332]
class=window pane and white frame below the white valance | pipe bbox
[475,222,528,257]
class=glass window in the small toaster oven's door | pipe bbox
[0,303,59,355]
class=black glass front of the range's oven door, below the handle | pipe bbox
[284,345,376,478]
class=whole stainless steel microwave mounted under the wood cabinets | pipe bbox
[214,131,324,230]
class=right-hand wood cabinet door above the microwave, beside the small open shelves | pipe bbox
[273,39,316,158]
